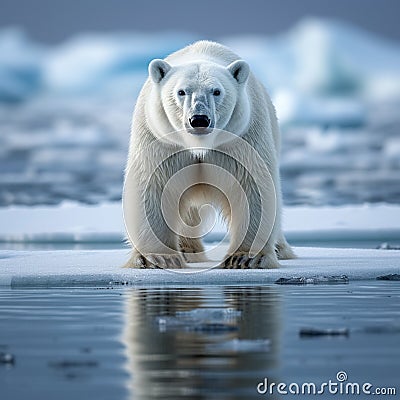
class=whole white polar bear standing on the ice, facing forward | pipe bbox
[123,41,295,269]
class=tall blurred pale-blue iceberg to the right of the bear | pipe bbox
[223,18,400,100]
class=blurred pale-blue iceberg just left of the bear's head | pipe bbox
[44,33,193,94]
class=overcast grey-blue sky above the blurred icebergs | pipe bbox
[0,0,400,43]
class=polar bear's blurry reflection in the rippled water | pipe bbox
[124,286,280,400]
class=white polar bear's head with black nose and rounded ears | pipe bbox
[147,59,250,146]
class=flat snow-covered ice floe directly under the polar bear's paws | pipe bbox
[0,247,400,287]
